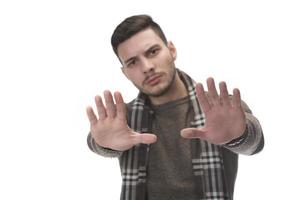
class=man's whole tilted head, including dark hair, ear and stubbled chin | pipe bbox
[111,15,184,100]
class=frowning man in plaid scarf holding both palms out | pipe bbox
[87,15,264,200]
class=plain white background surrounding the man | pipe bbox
[0,0,300,200]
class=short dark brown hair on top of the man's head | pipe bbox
[111,15,167,56]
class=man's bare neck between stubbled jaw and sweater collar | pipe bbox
[149,73,188,105]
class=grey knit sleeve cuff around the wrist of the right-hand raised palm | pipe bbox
[224,102,264,155]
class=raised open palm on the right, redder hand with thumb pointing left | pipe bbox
[181,78,246,144]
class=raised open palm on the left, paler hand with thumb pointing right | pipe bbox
[86,91,157,151]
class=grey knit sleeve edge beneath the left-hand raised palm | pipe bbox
[87,133,122,158]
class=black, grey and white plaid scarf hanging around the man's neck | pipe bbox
[119,69,232,200]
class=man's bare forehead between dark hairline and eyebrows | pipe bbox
[118,28,164,60]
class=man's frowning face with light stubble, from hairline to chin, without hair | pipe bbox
[118,28,176,97]
